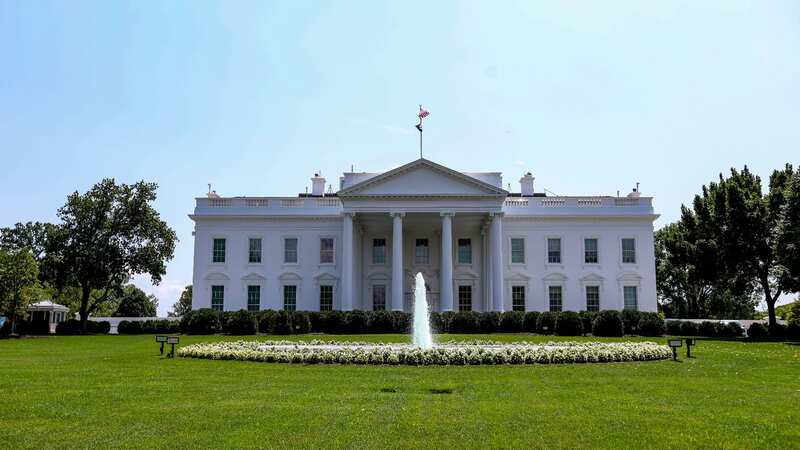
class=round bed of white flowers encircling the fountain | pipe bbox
[178,341,672,366]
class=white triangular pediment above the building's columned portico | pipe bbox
[339,159,508,197]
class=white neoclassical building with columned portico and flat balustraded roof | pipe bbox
[190,159,658,311]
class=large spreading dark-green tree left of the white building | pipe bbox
[48,179,177,330]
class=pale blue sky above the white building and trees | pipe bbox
[0,0,800,313]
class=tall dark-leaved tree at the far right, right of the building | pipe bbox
[668,164,800,326]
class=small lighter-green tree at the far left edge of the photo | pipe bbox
[0,249,39,332]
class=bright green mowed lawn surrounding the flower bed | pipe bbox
[0,335,800,449]
